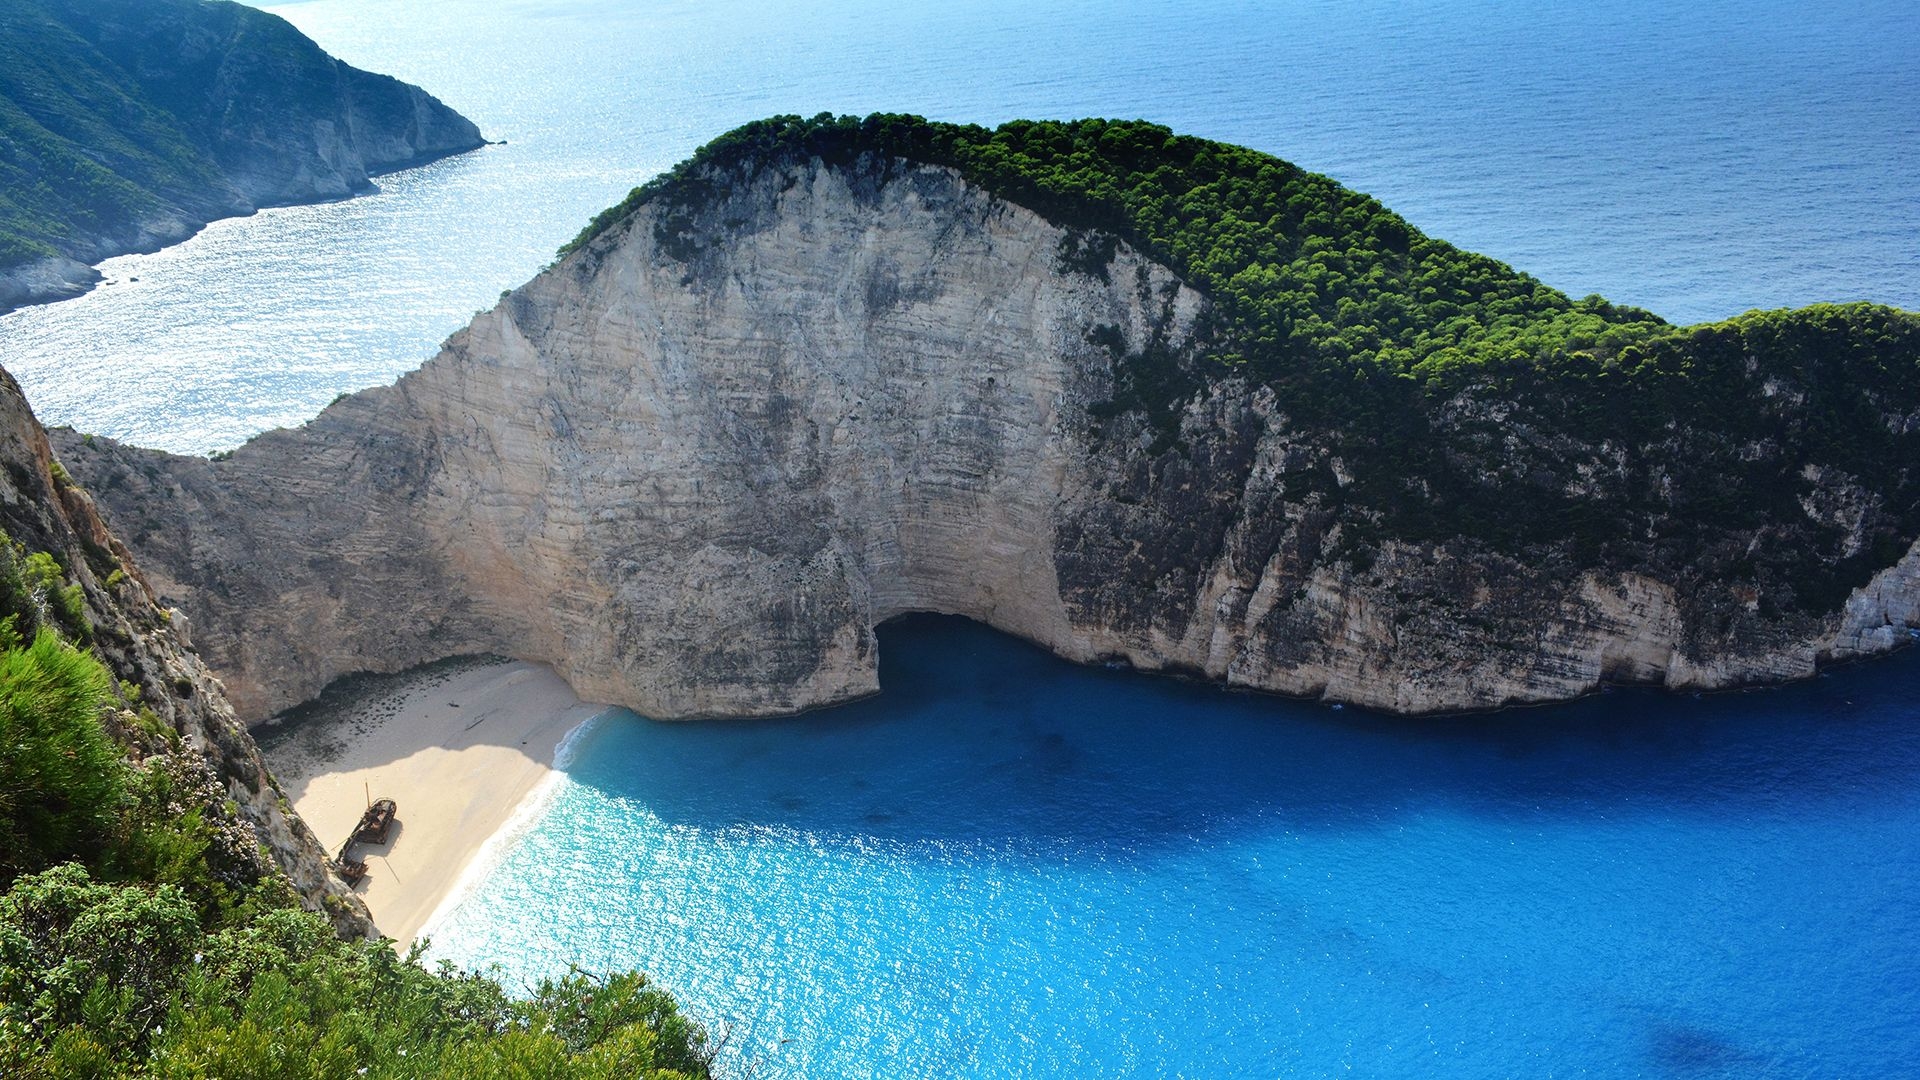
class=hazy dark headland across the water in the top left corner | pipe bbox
[0,0,484,311]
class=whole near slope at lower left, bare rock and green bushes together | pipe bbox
[0,371,712,1080]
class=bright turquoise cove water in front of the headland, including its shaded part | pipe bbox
[434,617,1920,1078]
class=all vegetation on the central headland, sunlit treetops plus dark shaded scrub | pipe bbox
[561,113,1920,611]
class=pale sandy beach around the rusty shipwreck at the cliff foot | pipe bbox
[253,659,605,945]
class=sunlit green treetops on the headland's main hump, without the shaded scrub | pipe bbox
[561,113,1665,377]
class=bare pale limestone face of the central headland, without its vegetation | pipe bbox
[60,161,1920,719]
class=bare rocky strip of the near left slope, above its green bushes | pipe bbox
[0,371,374,936]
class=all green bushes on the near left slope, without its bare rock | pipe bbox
[0,518,712,1080]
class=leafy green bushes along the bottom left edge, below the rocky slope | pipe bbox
[0,865,710,1080]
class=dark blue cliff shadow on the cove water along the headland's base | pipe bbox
[570,615,1920,849]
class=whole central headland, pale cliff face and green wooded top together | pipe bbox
[56,117,1920,719]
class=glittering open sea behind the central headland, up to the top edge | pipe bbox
[0,0,1920,452]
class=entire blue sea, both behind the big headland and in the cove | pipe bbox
[0,0,1920,1078]
